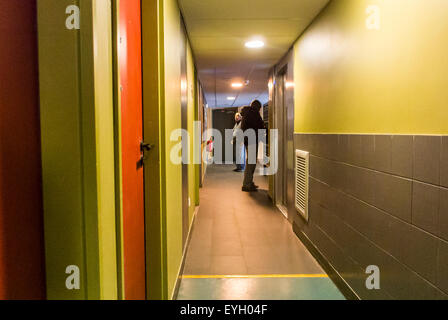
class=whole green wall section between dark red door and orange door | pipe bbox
[38,0,117,299]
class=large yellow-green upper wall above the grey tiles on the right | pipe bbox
[294,0,448,134]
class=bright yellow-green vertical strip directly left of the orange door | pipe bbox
[92,0,117,299]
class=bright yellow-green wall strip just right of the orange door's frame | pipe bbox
[162,0,183,296]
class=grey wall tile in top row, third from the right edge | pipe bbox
[391,135,414,178]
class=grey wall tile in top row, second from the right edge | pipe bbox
[414,136,442,185]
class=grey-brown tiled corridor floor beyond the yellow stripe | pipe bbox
[184,165,325,275]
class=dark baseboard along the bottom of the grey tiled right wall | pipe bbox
[292,223,361,300]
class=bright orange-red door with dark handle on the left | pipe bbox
[117,0,146,300]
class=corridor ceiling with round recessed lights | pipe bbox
[178,0,329,107]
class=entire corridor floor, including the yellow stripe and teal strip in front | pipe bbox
[178,165,344,300]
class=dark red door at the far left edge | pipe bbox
[0,0,45,300]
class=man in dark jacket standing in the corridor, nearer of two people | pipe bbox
[241,100,265,192]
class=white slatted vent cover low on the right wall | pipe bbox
[295,150,310,221]
